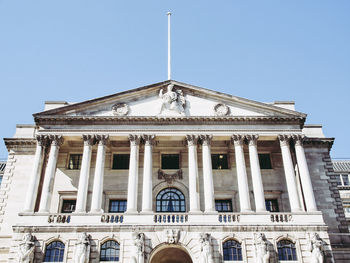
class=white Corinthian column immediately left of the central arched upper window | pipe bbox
[142,135,155,213]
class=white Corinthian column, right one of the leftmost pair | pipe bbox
[39,135,63,213]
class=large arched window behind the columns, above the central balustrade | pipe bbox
[157,188,186,212]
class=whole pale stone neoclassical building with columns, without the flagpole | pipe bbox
[0,81,350,263]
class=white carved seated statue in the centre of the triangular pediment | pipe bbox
[159,84,186,116]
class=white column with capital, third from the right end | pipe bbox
[246,135,266,212]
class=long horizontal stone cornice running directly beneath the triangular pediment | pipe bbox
[34,115,305,128]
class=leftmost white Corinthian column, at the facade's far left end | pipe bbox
[23,135,47,212]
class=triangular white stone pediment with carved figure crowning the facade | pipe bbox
[34,80,306,118]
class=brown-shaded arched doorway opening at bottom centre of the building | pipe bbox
[150,246,193,263]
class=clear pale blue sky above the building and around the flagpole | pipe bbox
[0,0,350,158]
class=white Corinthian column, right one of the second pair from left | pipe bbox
[91,135,109,213]
